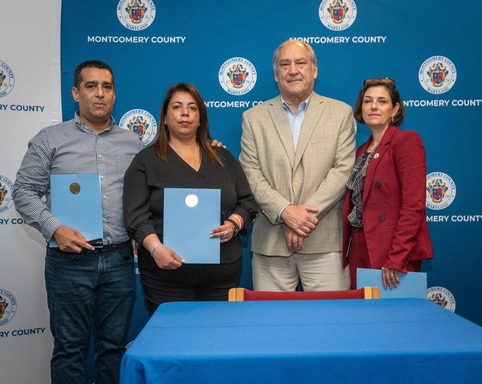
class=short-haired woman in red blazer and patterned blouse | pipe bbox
[342,79,433,289]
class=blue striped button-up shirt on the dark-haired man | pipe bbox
[13,113,143,244]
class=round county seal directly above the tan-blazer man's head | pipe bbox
[318,0,357,31]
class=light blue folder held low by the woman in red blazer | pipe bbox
[356,268,427,299]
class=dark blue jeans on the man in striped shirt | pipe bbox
[45,245,135,384]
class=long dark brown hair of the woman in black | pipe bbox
[152,83,223,165]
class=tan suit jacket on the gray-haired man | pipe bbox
[240,93,355,256]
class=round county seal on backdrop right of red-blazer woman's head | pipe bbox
[418,56,457,94]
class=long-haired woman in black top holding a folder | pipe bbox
[124,83,258,313]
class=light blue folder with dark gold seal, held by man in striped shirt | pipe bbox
[50,173,103,247]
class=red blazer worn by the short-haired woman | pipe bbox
[342,126,433,273]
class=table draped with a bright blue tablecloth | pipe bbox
[121,299,482,384]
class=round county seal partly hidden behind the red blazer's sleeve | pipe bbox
[425,172,457,210]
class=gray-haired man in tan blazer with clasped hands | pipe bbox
[240,40,355,291]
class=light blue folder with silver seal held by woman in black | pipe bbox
[163,188,221,264]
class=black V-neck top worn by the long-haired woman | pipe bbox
[124,147,258,263]
